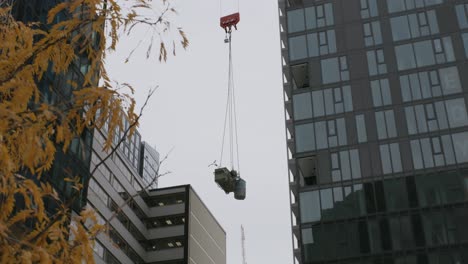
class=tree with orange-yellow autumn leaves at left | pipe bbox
[0,0,188,263]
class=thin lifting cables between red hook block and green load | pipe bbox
[219,28,240,174]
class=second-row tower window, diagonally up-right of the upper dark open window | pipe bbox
[307,30,336,57]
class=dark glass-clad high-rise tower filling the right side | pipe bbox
[279,0,468,264]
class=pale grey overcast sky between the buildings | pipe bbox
[108,0,292,264]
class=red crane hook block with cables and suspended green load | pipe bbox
[214,4,246,200]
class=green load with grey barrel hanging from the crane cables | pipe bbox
[214,167,247,200]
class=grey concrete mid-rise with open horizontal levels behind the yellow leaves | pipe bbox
[88,125,226,264]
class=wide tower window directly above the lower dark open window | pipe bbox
[296,118,347,152]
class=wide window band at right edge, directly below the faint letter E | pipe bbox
[405,98,468,135]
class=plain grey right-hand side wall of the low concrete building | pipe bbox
[188,188,226,264]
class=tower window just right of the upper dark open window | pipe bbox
[320,56,349,84]
